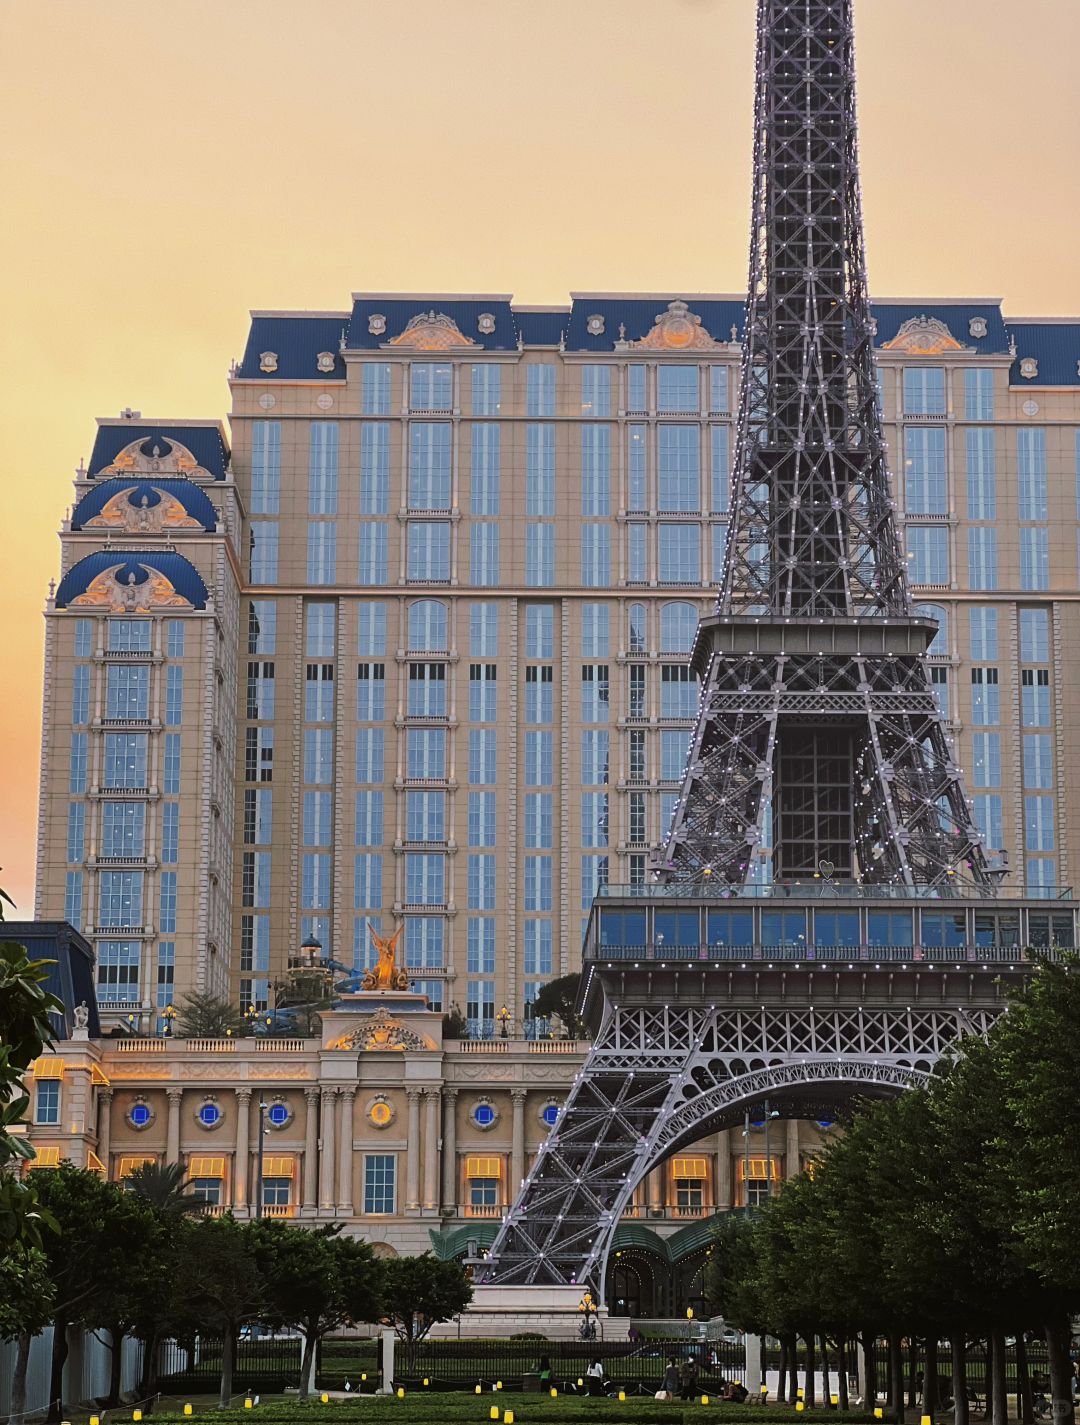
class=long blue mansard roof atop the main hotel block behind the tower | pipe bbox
[235,292,1080,384]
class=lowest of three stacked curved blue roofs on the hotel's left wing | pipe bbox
[56,549,209,614]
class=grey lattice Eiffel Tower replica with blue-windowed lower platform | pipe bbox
[474,0,1076,1301]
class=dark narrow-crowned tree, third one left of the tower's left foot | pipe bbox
[177,1217,268,1409]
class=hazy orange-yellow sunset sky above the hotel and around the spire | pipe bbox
[0,0,1080,915]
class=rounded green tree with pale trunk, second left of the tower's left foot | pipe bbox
[251,1220,383,1399]
